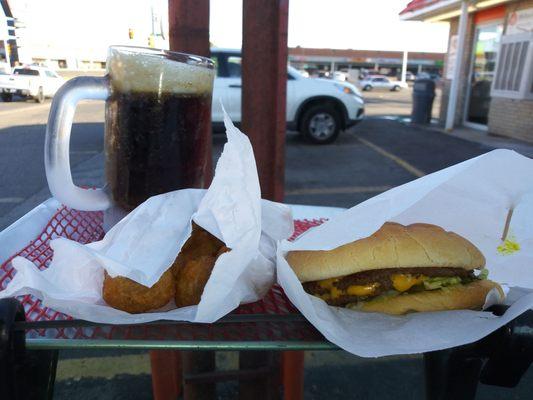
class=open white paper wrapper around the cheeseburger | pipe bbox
[277,150,533,357]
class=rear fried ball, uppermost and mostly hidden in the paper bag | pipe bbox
[172,222,224,277]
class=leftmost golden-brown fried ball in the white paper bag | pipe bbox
[102,268,175,314]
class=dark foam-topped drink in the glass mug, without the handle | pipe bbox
[105,47,214,210]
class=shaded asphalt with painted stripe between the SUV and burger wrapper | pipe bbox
[285,118,492,207]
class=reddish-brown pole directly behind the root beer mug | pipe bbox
[168,0,213,187]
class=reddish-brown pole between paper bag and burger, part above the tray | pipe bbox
[242,0,289,201]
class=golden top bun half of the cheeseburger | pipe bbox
[287,222,485,282]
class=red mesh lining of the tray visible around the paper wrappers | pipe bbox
[0,207,325,341]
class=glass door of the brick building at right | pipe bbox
[465,22,503,126]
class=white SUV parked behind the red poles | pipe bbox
[211,49,364,144]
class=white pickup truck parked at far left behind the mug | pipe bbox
[0,66,65,103]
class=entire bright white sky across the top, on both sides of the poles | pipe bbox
[9,0,448,62]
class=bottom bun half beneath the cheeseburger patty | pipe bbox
[346,280,504,315]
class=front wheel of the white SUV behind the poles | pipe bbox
[300,105,341,144]
